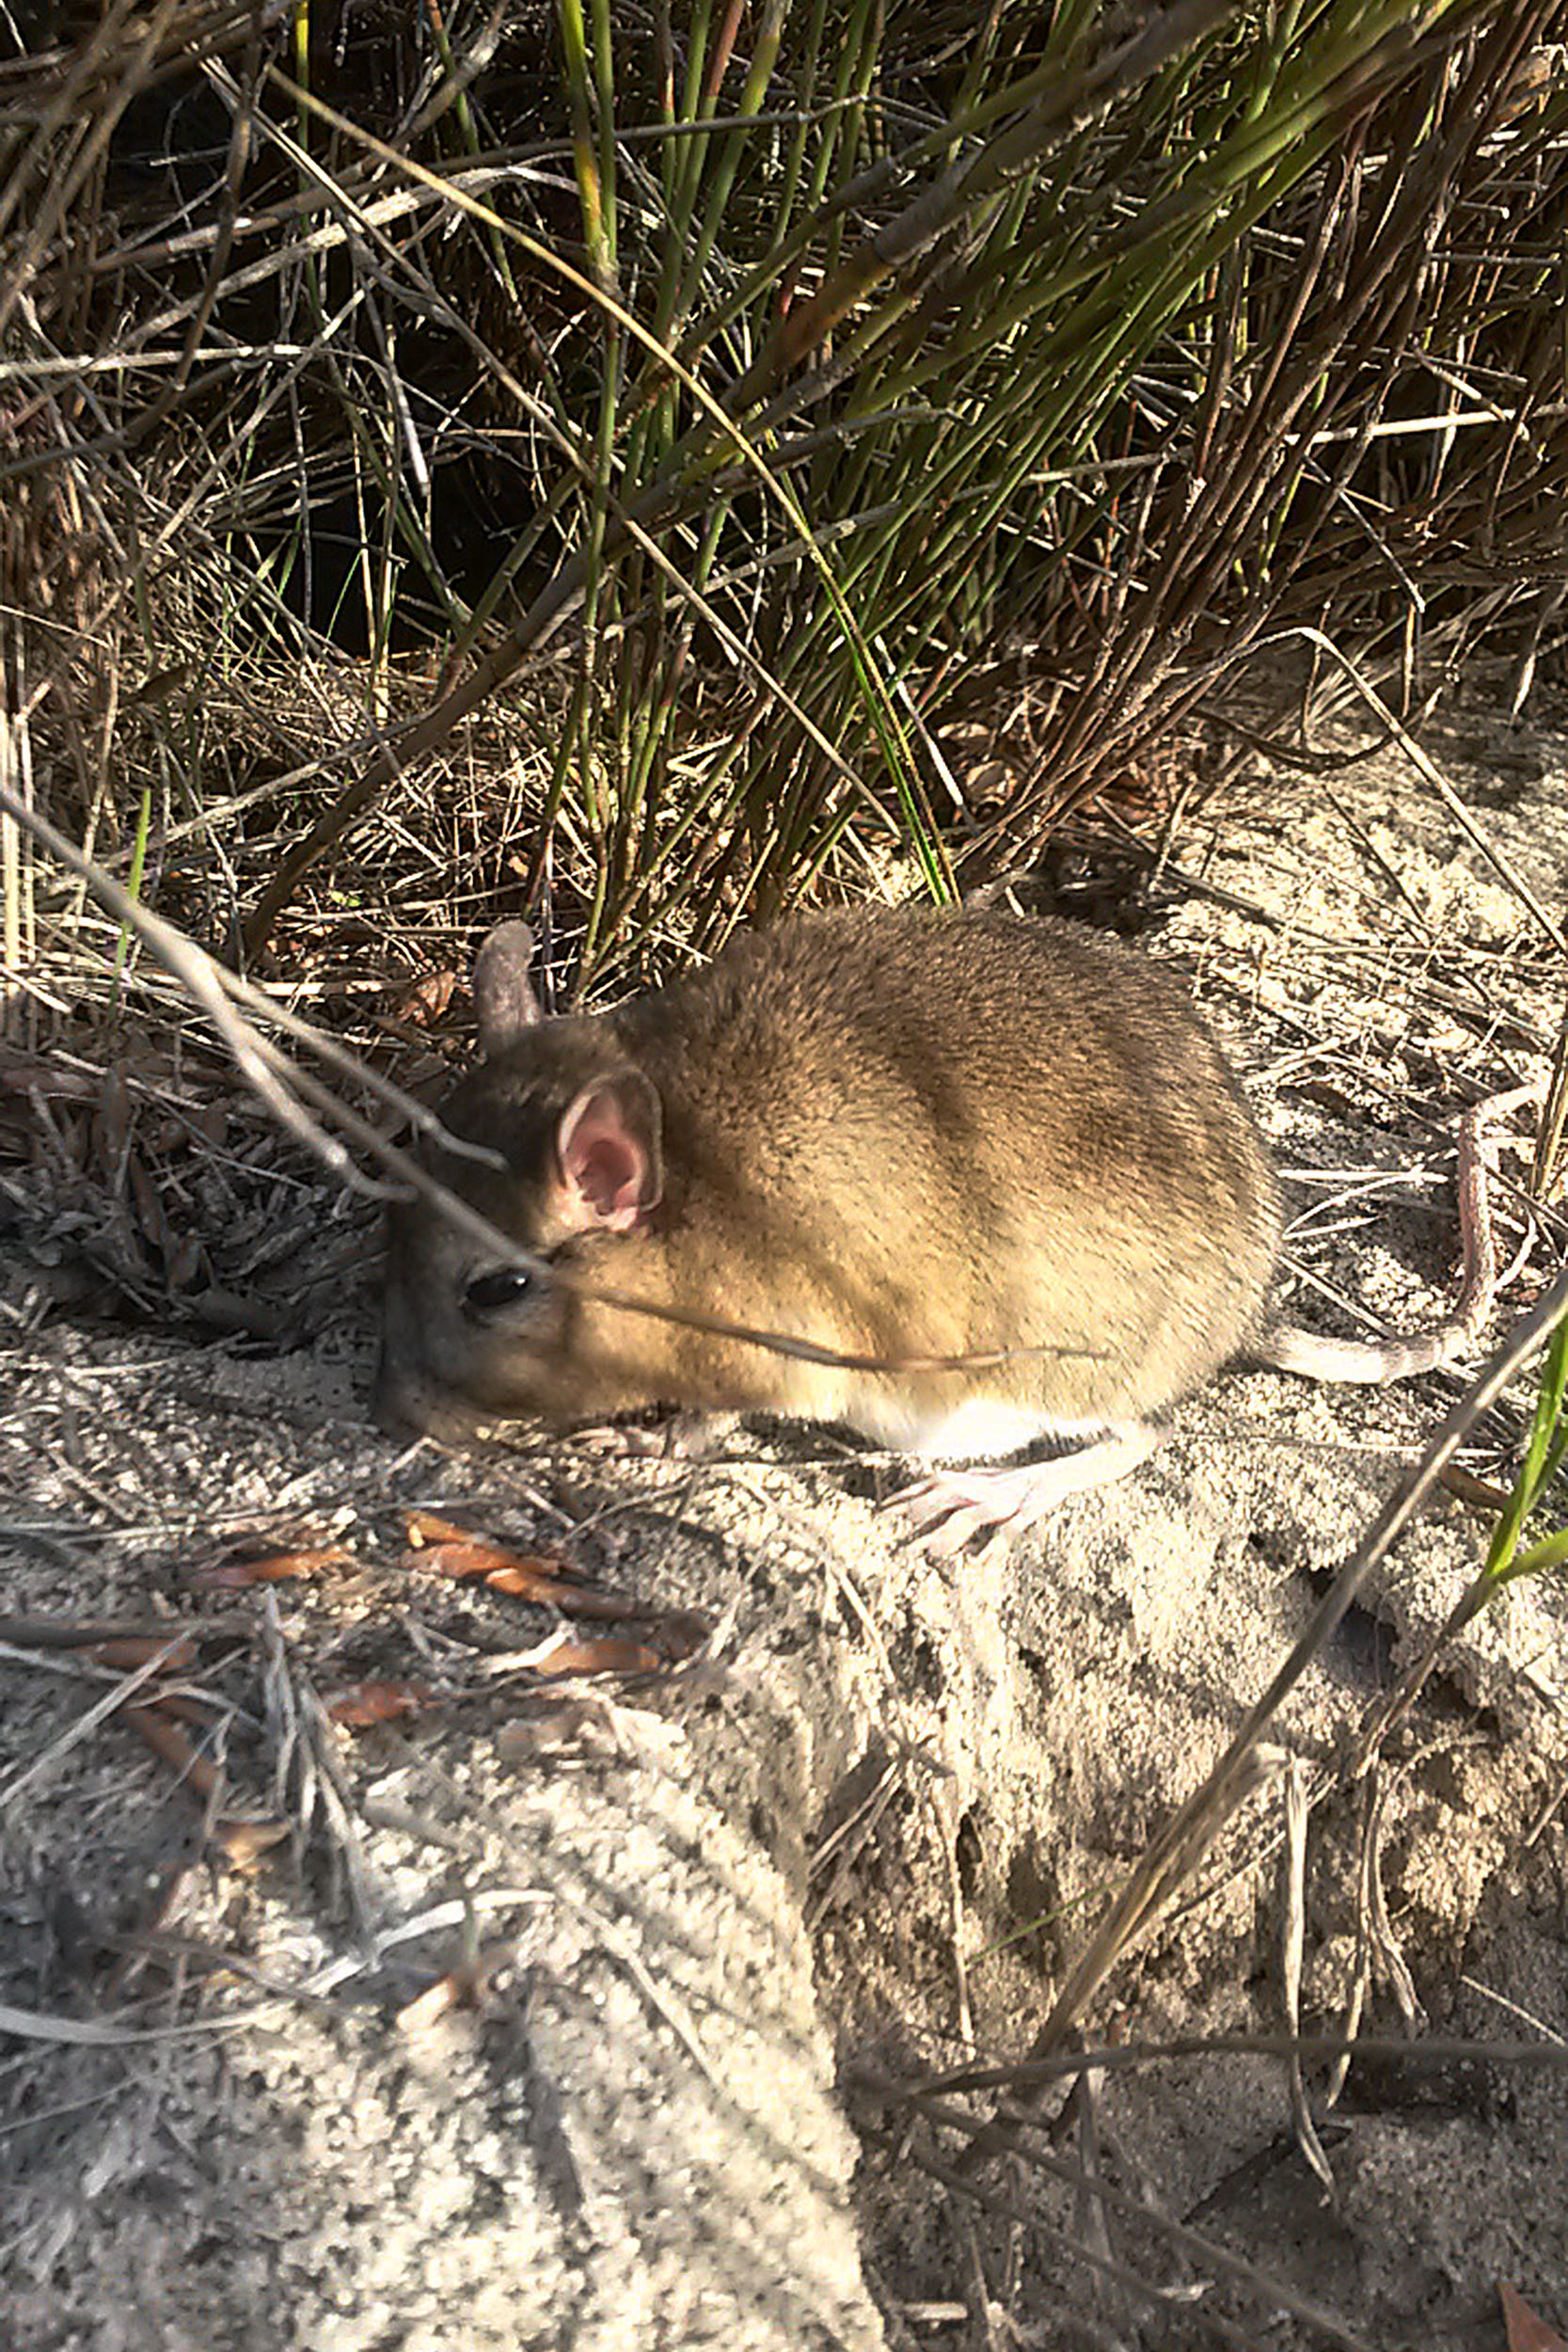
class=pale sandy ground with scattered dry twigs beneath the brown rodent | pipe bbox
[0,673,1568,2352]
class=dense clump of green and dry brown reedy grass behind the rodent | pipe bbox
[0,0,1568,967]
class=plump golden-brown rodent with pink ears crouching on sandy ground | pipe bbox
[376,908,1504,1532]
